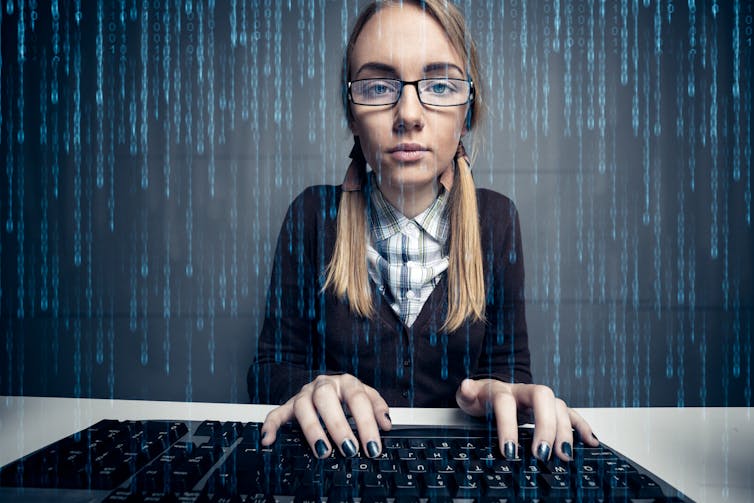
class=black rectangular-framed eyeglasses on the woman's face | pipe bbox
[348,77,474,107]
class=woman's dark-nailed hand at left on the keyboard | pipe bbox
[261,374,392,458]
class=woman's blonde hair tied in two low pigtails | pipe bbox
[323,0,485,332]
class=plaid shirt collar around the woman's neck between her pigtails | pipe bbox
[369,171,450,244]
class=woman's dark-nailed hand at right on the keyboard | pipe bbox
[456,379,599,461]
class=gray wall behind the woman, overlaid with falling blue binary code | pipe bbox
[0,0,754,406]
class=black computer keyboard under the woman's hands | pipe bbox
[0,420,690,503]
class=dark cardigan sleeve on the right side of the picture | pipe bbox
[471,194,532,383]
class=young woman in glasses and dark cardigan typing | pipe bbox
[248,0,598,460]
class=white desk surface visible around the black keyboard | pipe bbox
[0,396,754,502]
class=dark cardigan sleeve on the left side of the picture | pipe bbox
[247,188,320,404]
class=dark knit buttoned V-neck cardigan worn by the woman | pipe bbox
[247,185,531,407]
